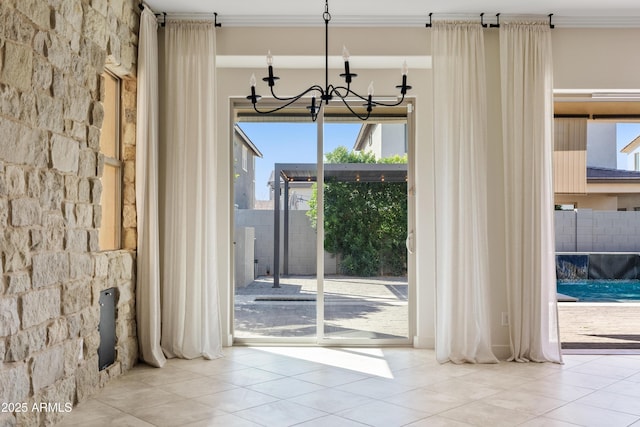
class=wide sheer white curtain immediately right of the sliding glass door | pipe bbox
[432,22,497,363]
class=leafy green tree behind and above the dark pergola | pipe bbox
[307,147,407,276]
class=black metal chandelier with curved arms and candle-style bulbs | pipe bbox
[247,0,411,122]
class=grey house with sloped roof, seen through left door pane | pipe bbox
[233,125,262,209]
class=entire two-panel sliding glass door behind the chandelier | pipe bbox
[233,105,413,345]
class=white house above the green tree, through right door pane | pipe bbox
[353,123,407,159]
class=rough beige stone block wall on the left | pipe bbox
[0,0,139,426]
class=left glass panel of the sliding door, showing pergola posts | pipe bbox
[233,121,317,342]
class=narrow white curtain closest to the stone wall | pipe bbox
[136,7,166,367]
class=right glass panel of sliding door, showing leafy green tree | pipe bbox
[322,120,409,343]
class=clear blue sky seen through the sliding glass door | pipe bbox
[238,121,362,200]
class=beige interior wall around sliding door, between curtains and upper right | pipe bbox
[218,26,640,355]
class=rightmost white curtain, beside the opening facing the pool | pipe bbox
[500,23,562,362]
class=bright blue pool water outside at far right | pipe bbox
[557,280,640,302]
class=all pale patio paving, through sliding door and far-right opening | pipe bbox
[234,276,640,351]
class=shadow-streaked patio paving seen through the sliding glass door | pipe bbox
[234,276,409,338]
